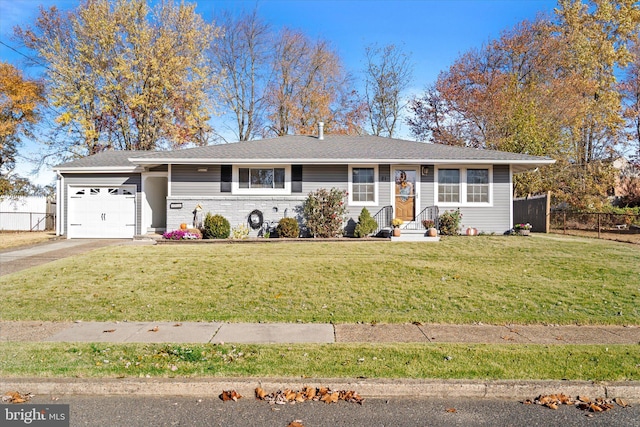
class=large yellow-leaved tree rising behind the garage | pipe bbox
[15,0,216,155]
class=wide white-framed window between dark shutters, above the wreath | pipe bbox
[232,165,291,195]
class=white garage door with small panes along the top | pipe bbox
[67,187,136,239]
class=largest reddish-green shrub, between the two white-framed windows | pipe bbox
[303,188,347,237]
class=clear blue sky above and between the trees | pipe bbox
[0,0,557,184]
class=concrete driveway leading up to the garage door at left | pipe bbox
[0,239,154,276]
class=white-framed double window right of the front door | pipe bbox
[436,168,492,205]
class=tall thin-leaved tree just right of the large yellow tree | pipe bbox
[211,10,272,141]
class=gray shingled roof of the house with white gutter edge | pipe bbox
[55,135,554,172]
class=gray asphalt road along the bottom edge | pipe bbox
[14,396,640,427]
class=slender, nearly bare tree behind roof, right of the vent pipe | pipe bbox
[364,44,412,138]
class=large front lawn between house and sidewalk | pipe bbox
[0,235,640,325]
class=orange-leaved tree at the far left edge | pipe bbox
[0,62,45,197]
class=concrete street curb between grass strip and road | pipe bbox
[5,378,640,402]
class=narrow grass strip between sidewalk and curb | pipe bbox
[0,342,640,381]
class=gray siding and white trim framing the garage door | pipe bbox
[62,173,142,235]
